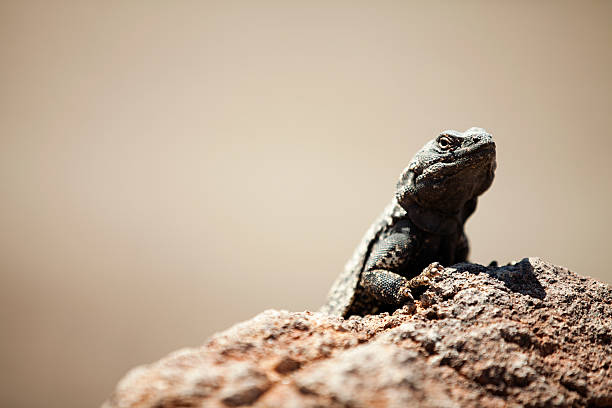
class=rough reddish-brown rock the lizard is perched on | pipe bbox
[103,258,612,408]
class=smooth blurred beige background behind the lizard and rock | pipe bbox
[0,1,612,407]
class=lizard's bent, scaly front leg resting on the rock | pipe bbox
[360,233,417,306]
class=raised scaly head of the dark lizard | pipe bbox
[396,127,496,215]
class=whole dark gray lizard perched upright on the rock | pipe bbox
[321,127,496,317]
